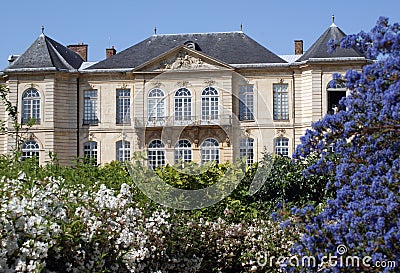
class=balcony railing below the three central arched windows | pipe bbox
[135,115,232,128]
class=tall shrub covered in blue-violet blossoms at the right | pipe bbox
[294,17,400,272]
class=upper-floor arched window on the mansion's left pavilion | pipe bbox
[22,88,40,124]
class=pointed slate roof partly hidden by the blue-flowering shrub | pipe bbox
[297,24,364,62]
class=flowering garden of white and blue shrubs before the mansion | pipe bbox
[0,17,400,273]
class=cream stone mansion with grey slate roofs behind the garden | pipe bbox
[0,23,369,167]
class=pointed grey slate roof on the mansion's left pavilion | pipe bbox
[4,33,83,72]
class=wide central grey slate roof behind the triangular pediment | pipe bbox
[86,31,286,70]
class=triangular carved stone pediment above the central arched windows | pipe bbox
[134,45,234,72]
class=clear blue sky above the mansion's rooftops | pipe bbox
[0,0,400,70]
